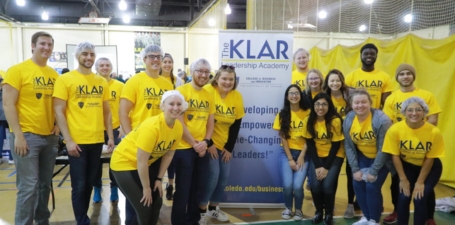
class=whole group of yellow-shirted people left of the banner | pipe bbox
[2,32,244,224]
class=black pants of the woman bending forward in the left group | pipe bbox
[113,158,163,225]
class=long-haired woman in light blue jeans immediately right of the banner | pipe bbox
[273,84,309,220]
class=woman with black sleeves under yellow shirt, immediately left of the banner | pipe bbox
[199,65,245,224]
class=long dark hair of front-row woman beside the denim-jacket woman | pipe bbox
[307,92,343,138]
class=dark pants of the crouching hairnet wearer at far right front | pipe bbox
[398,159,442,225]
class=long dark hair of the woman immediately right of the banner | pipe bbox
[279,84,310,139]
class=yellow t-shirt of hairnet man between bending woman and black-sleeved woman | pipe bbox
[176,83,215,150]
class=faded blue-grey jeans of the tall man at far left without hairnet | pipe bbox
[9,133,58,225]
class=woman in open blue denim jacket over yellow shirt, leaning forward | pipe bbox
[343,89,394,225]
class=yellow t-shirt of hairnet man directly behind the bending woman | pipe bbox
[121,72,174,128]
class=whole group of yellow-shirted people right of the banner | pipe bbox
[273,44,444,225]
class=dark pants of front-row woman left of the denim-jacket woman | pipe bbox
[309,157,343,214]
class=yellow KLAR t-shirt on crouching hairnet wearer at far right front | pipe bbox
[382,121,445,166]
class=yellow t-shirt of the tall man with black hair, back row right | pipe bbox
[345,68,394,109]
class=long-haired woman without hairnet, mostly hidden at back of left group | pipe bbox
[160,53,184,200]
